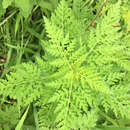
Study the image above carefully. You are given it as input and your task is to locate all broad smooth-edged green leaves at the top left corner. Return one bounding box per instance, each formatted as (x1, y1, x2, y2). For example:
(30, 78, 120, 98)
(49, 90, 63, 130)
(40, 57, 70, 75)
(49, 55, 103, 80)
(0, 0, 58, 18)
